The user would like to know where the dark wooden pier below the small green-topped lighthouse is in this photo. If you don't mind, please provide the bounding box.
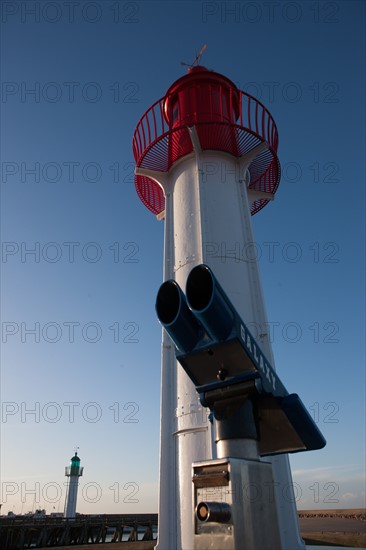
[0,514,158,550]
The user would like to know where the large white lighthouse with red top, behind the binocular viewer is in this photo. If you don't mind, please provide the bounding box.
[133,61,320,550]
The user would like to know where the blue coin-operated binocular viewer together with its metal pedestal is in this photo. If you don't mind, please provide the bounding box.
[156,264,325,550]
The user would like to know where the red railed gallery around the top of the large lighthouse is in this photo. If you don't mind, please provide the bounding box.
[133,85,280,214]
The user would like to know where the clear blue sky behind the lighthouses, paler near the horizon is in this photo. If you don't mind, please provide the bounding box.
[1,0,365,513]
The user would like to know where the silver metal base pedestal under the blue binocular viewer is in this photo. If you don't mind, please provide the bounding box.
[193,458,281,550]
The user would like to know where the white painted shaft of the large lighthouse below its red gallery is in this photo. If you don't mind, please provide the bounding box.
[147,129,305,550]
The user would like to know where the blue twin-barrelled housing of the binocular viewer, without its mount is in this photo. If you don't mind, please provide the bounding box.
[156,264,326,455]
